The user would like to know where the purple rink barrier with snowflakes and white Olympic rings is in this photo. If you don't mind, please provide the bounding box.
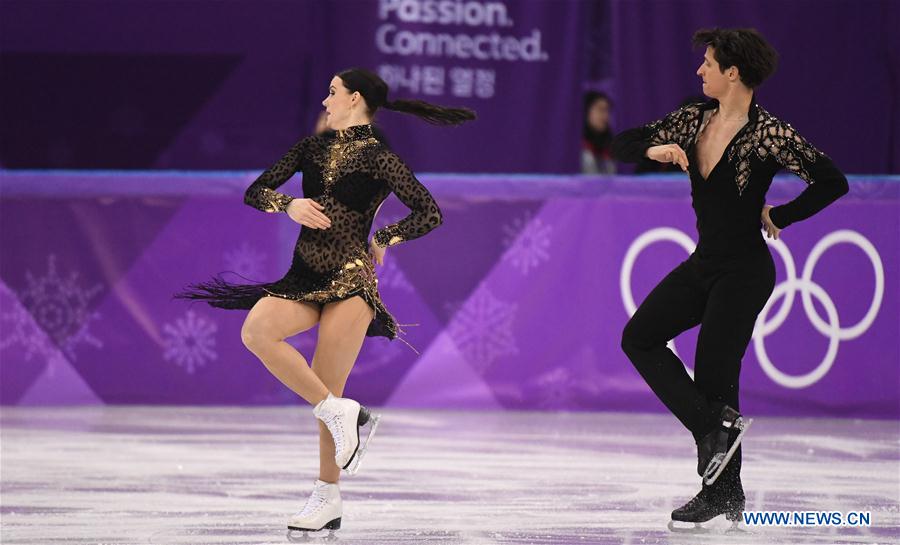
[0,171,900,419]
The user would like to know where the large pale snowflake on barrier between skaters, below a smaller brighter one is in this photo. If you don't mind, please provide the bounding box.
[447,286,519,374]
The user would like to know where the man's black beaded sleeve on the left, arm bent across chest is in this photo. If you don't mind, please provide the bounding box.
[612,104,701,163]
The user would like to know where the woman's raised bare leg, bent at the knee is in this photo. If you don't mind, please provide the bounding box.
[241,297,334,404]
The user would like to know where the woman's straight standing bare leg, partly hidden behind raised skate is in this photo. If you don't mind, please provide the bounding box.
[312,297,374,483]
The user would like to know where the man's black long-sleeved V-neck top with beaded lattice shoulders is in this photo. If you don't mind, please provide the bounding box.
[612,100,849,255]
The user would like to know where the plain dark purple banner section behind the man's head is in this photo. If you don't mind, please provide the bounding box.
[612,0,900,173]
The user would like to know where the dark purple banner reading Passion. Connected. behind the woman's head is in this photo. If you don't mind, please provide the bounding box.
[0,0,584,172]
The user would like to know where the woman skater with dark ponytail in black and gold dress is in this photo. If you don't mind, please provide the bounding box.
[177,68,475,535]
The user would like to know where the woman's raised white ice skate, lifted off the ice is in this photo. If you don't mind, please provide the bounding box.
[313,394,381,475]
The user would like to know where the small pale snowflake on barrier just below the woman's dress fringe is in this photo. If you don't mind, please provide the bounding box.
[163,310,218,374]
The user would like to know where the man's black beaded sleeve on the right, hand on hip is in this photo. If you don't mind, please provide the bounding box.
[760,117,850,229]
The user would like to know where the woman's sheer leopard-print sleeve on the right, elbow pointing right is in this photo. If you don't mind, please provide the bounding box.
[374,150,443,248]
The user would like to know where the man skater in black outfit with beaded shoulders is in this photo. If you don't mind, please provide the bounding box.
[613,28,848,527]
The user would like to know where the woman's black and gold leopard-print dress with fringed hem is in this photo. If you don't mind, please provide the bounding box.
[177,125,442,339]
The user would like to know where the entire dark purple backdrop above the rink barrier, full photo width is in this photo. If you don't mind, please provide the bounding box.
[0,0,900,173]
